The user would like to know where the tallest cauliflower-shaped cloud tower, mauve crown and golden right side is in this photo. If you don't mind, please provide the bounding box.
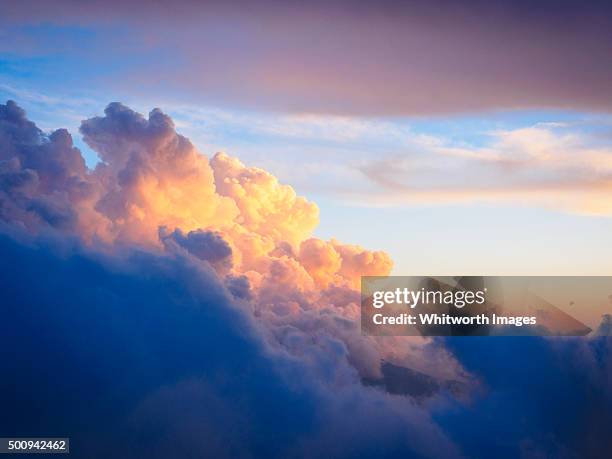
[81,103,238,242]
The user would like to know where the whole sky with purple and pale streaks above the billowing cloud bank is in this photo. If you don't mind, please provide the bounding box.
[0,1,612,275]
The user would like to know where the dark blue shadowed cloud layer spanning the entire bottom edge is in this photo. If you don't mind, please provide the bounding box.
[0,224,612,458]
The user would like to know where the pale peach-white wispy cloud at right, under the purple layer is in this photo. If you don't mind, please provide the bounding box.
[359,124,612,215]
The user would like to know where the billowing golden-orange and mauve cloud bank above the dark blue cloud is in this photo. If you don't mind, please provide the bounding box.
[2,103,430,396]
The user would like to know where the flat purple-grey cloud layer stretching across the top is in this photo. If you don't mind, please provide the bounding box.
[3,0,612,116]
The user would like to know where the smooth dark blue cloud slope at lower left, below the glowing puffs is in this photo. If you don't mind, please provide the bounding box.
[0,228,457,458]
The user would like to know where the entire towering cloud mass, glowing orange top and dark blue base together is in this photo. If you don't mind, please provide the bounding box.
[0,103,612,458]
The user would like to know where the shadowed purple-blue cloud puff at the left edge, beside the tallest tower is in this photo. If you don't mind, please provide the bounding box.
[0,101,92,234]
